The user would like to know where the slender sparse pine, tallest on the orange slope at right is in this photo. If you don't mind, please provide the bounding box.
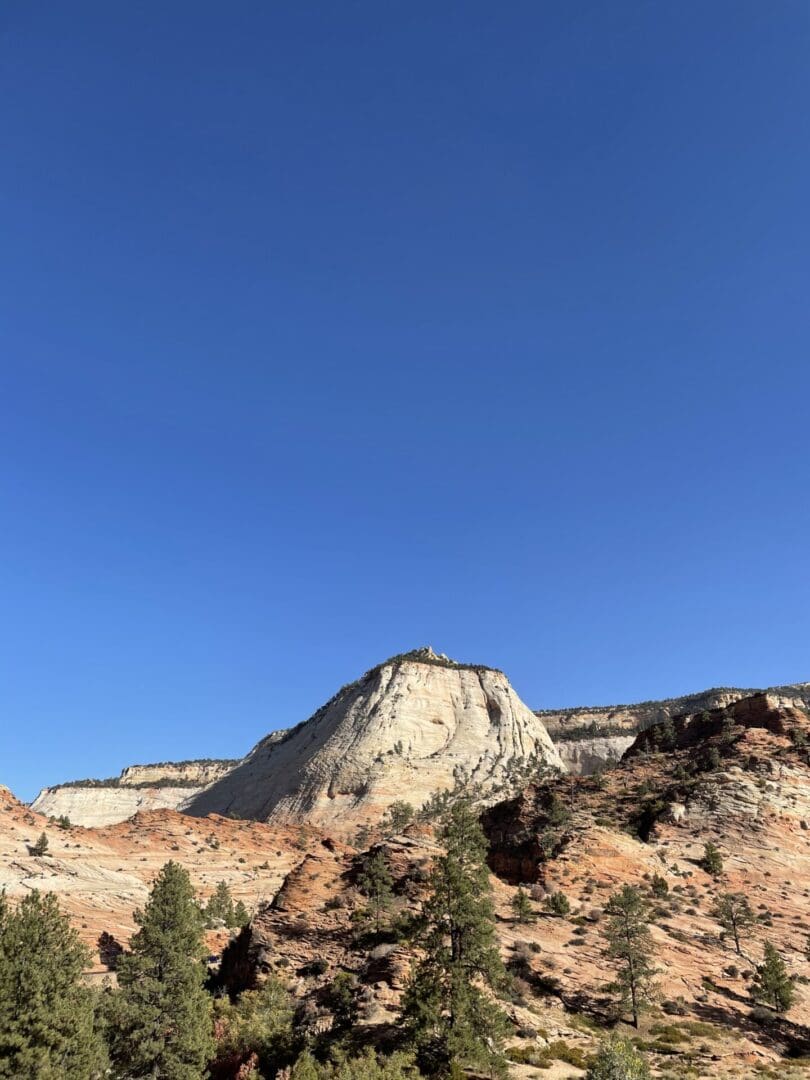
[605,885,656,1027]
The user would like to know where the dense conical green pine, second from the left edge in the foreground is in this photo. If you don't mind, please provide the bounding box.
[111,862,214,1080]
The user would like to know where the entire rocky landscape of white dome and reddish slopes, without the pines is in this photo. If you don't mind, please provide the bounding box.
[0,650,810,1080]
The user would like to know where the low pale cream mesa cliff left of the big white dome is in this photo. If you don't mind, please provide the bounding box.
[31,759,238,826]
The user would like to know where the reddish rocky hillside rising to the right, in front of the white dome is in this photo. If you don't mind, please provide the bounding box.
[213,694,810,1078]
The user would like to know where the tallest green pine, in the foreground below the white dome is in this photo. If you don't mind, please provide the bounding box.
[402,799,507,1075]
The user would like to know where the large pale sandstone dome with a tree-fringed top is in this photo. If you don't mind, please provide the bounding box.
[189,650,562,835]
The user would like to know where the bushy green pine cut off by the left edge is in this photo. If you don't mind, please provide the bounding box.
[0,891,107,1080]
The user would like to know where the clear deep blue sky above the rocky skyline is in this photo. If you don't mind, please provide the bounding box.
[0,0,810,797]
